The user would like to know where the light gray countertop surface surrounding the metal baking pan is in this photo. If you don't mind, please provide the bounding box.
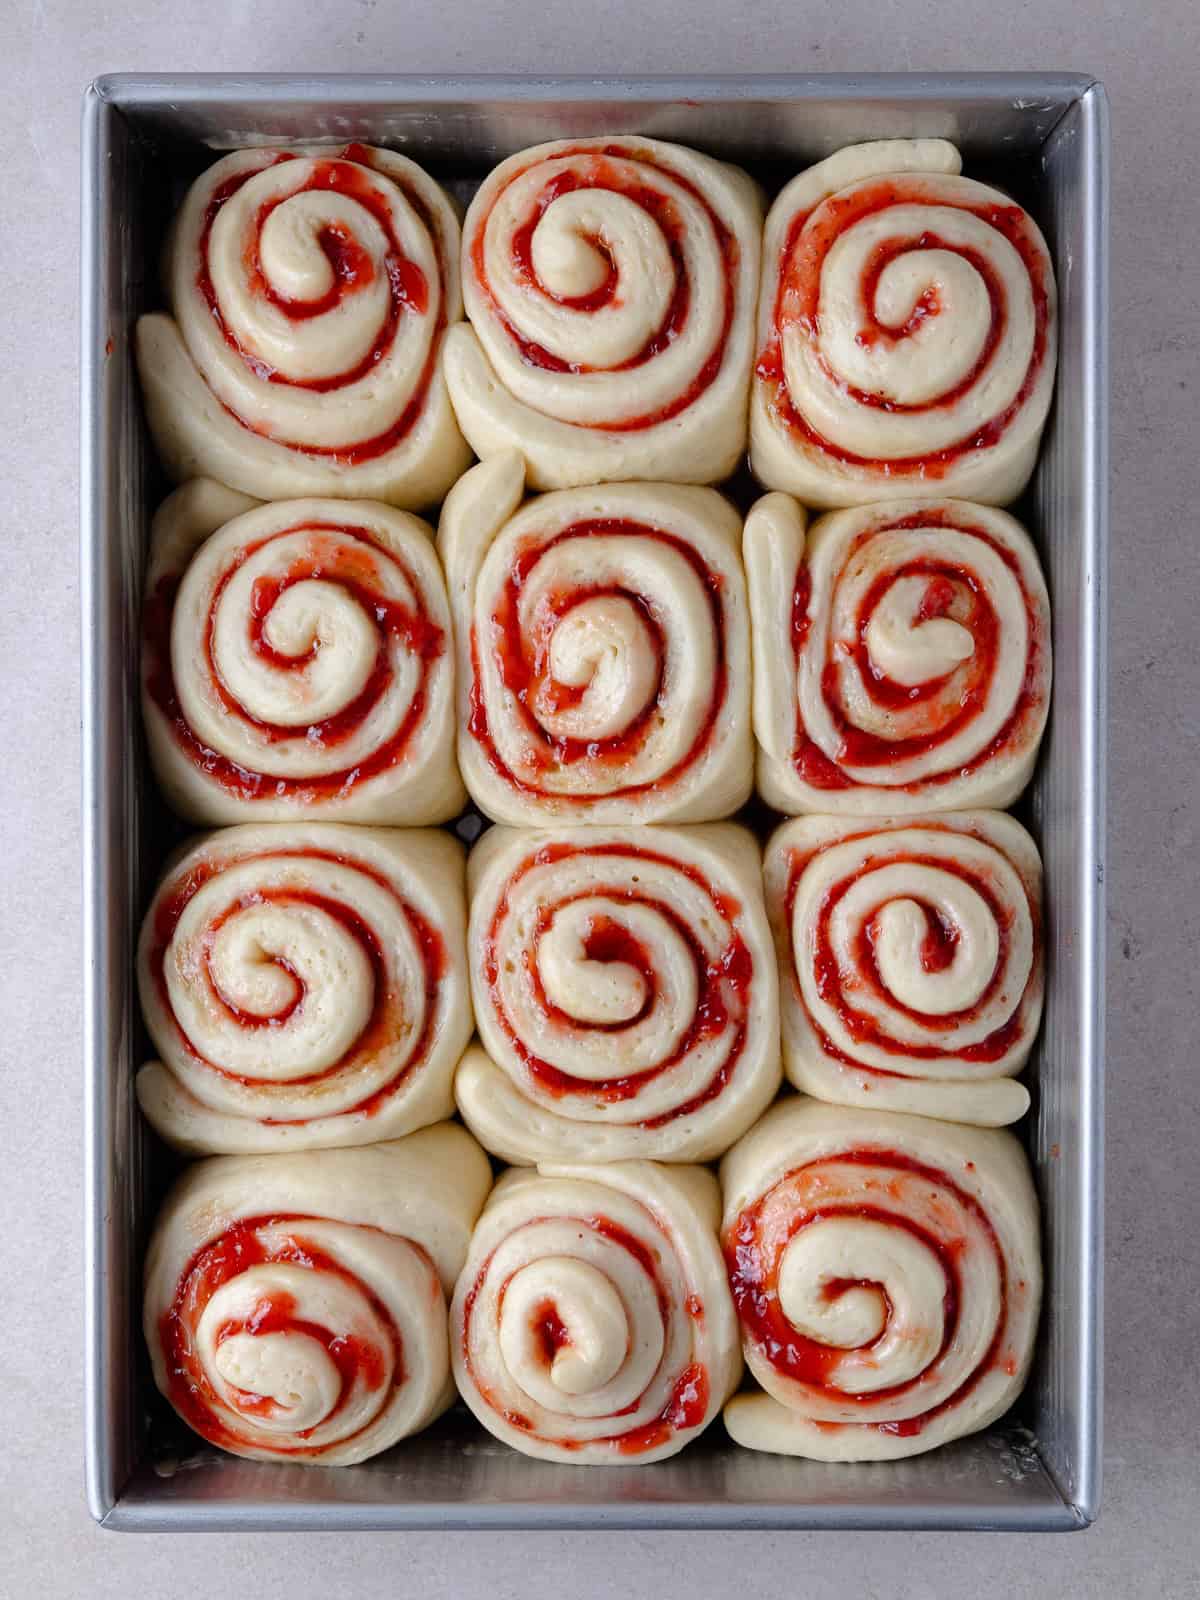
[0,0,1200,1600]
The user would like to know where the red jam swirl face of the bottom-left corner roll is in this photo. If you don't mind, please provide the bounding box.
[157,1216,405,1459]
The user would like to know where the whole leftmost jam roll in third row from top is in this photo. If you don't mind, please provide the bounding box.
[138,822,472,1154]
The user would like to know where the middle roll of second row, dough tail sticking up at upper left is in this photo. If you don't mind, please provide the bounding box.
[438,451,754,826]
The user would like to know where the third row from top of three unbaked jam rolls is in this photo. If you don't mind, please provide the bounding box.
[138,811,1043,1163]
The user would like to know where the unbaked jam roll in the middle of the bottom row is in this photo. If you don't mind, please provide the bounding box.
[450,1162,742,1466]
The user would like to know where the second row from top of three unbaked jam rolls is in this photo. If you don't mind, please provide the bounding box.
[142,451,1051,826]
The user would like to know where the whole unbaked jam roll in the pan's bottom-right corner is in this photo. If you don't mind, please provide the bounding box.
[722,1098,1042,1461]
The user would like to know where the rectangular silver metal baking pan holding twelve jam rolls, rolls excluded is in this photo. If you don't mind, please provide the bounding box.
[82,74,1107,1530]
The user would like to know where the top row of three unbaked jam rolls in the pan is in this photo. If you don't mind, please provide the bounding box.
[136,134,1056,510]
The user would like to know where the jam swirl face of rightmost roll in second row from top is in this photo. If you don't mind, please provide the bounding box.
[792,502,1050,803]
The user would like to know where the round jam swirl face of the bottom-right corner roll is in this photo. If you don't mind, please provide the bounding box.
[723,1147,1022,1438]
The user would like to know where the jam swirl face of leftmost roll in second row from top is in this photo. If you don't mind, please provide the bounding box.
[142,520,448,805]
